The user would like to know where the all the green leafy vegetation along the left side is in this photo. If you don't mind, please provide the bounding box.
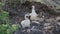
[0,2,20,34]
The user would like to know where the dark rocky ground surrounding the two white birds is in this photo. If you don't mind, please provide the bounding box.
[3,2,60,34]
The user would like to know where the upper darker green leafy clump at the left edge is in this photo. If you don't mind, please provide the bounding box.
[0,11,10,23]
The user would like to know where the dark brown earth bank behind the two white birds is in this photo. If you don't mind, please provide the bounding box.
[3,1,59,23]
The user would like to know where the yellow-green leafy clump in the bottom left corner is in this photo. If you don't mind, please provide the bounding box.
[0,24,19,34]
